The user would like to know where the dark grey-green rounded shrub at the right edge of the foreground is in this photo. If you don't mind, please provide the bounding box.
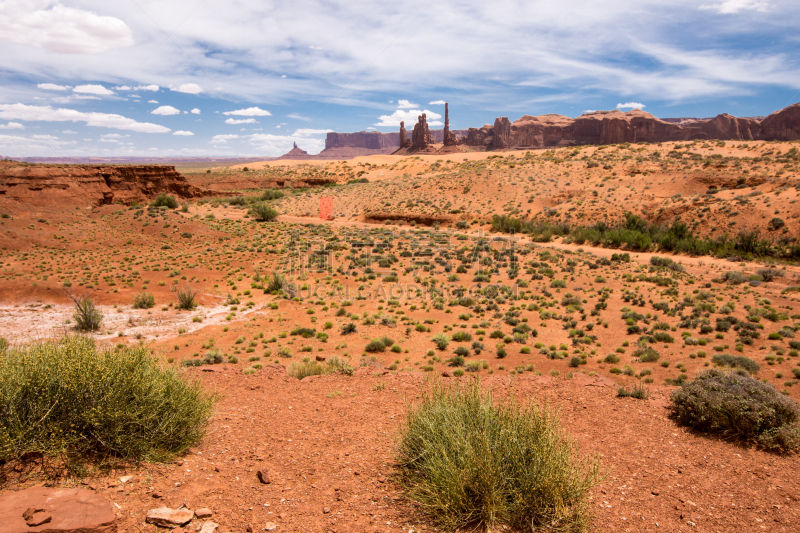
[670,369,800,451]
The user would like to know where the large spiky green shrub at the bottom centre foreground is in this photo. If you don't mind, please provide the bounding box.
[397,380,601,531]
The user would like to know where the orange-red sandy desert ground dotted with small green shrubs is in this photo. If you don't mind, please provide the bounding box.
[0,113,800,531]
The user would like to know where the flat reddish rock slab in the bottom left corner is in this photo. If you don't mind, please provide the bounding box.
[0,487,117,533]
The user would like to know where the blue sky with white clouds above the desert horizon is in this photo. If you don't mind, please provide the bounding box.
[0,0,800,157]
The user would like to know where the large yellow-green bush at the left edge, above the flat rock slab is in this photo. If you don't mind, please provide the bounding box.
[0,336,216,461]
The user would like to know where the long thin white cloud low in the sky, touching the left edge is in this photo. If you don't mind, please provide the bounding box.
[0,104,171,133]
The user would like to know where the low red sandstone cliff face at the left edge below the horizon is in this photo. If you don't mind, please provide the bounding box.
[0,162,208,206]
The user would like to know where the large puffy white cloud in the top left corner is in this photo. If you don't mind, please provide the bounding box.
[0,0,133,54]
